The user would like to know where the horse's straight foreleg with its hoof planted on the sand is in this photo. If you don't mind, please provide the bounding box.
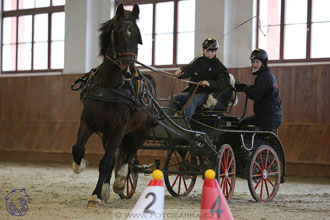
[87,129,124,208]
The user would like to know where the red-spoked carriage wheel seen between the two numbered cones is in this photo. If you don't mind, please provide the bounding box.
[164,150,197,197]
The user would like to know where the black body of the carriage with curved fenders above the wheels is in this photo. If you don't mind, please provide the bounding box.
[141,113,285,180]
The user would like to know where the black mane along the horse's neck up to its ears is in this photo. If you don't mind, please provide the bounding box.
[99,9,139,57]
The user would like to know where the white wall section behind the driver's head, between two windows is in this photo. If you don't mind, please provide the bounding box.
[195,0,256,67]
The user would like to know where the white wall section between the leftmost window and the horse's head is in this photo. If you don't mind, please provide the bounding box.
[64,0,113,74]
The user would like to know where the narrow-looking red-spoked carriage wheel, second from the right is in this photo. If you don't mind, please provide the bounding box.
[215,144,236,201]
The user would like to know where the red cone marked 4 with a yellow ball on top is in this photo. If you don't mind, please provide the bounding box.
[200,169,234,220]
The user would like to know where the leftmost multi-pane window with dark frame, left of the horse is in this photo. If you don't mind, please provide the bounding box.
[1,0,65,73]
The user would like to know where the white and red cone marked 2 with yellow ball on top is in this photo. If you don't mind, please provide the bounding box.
[127,170,165,220]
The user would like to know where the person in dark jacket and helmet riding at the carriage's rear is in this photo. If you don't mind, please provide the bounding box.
[241,49,283,131]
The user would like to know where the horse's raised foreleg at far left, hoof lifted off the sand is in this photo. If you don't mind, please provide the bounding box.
[72,120,93,174]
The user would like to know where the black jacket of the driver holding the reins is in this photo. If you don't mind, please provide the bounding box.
[179,56,229,94]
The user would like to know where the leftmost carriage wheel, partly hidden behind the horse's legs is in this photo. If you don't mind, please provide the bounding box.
[115,150,139,199]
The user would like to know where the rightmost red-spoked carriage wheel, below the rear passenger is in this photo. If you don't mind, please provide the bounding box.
[248,145,281,202]
